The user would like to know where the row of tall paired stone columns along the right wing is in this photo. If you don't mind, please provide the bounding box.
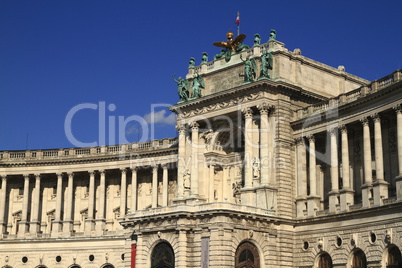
[295,105,402,217]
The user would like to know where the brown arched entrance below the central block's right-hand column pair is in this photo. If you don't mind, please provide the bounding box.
[235,242,260,268]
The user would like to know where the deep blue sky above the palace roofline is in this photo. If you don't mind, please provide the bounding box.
[0,0,402,150]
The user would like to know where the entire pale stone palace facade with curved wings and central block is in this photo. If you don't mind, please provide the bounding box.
[0,32,402,268]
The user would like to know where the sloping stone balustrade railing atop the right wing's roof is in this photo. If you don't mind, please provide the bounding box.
[296,70,402,120]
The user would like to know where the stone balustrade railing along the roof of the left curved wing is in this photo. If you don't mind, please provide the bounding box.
[0,138,177,161]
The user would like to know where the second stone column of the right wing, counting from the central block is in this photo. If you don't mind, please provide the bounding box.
[307,135,320,216]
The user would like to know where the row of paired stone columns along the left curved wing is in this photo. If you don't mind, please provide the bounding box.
[0,164,168,238]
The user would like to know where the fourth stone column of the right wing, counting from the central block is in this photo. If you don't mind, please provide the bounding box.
[339,125,354,211]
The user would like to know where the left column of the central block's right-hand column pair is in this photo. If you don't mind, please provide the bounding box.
[241,108,254,206]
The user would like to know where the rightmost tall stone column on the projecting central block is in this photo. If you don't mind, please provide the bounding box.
[258,103,272,186]
